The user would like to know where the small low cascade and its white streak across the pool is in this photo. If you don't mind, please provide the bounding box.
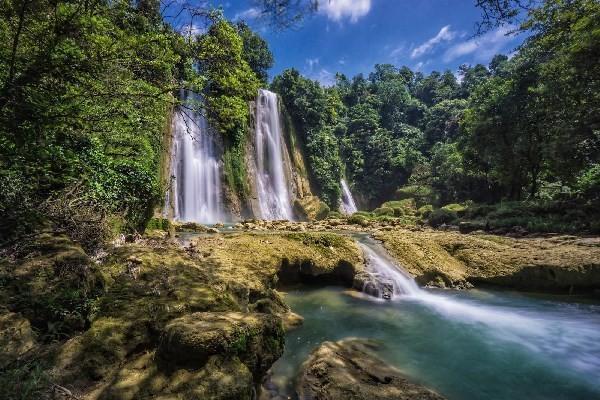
[361,241,600,378]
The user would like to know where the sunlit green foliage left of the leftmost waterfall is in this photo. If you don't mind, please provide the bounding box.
[0,1,180,241]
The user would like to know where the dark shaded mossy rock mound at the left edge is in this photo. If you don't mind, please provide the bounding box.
[0,233,103,340]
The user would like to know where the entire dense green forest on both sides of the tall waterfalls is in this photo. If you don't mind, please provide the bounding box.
[0,0,600,246]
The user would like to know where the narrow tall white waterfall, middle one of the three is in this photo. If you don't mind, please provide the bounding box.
[255,89,293,220]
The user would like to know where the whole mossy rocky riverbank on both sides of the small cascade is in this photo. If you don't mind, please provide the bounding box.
[0,225,600,399]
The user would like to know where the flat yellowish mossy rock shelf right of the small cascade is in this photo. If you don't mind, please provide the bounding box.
[377,230,600,291]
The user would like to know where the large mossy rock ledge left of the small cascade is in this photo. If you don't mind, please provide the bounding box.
[0,232,363,400]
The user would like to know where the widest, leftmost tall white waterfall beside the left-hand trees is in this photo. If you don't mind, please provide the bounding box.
[168,91,224,223]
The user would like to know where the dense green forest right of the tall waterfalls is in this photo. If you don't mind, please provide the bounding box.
[272,1,600,222]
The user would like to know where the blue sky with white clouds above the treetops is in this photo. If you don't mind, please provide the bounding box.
[197,0,523,85]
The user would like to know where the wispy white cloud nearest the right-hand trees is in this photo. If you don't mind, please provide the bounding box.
[444,26,514,62]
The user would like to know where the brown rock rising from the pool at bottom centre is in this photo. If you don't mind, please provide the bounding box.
[296,339,444,400]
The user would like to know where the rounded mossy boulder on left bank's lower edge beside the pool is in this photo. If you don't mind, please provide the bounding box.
[158,312,284,378]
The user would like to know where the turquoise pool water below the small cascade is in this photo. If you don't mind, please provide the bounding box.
[272,288,600,400]
